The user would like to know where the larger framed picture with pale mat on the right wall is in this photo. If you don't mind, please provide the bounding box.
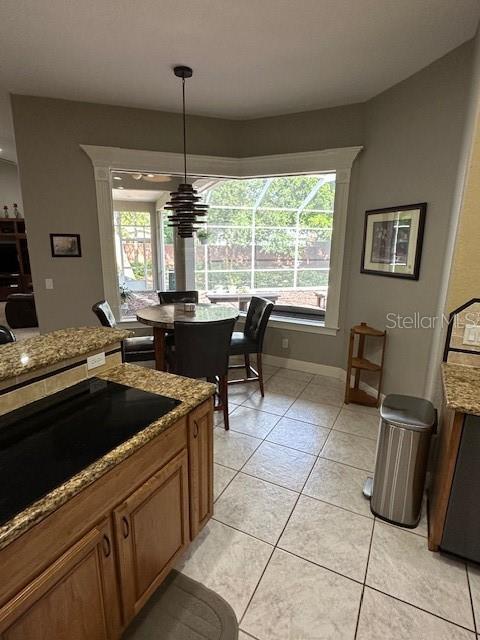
[361,202,427,280]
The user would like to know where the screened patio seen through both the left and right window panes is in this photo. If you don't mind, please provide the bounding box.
[114,172,335,319]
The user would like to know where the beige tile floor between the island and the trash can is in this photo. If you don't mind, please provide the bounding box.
[173,367,480,640]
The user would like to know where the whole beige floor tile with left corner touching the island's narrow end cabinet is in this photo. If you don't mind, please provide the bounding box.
[215,473,298,544]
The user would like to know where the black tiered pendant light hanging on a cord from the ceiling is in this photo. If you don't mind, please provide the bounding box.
[165,66,208,238]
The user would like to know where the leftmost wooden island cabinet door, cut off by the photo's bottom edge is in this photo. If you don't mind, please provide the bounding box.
[0,520,119,640]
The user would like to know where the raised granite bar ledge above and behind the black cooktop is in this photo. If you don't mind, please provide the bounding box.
[0,327,133,381]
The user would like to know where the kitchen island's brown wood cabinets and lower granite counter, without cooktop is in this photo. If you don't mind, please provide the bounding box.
[0,335,214,640]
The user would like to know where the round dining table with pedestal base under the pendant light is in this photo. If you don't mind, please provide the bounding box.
[137,302,239,371]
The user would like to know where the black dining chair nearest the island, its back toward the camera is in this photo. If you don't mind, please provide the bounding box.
[166,318,235,430]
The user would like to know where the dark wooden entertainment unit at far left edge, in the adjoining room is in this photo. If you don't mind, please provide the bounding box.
[0,218,33,302]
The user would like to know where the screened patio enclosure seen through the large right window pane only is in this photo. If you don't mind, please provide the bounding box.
[195,173,335,313]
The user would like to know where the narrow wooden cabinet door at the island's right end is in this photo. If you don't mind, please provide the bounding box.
[188,402,213,540]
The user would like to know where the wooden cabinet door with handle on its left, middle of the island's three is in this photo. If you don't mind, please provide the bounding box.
[114,449,189,624]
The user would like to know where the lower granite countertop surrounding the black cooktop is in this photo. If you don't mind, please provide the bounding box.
[0,364,215,549]
